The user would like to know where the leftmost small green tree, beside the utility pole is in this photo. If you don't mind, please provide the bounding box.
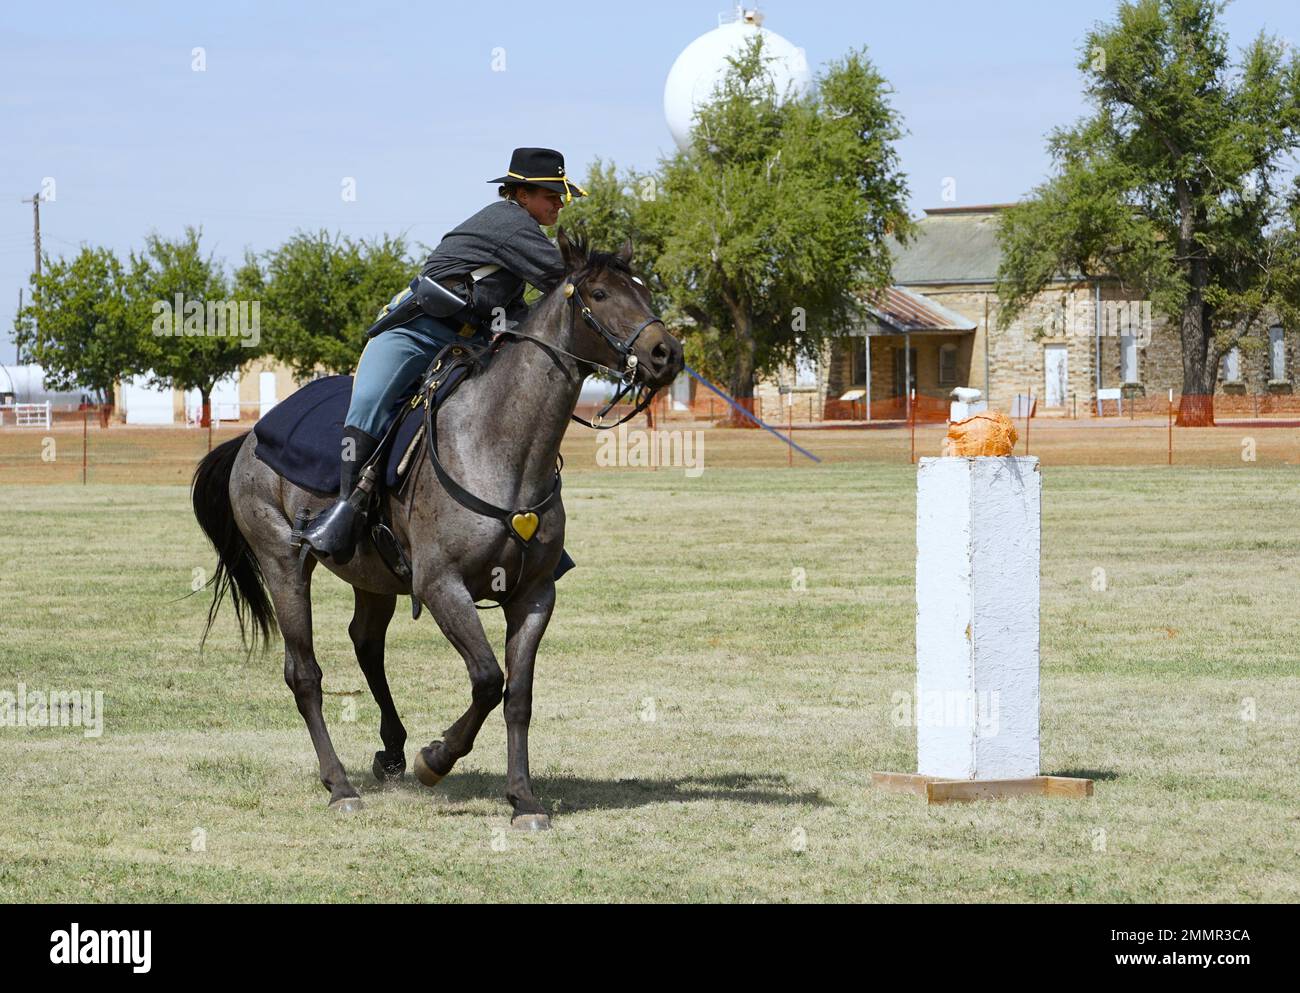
[14,246,140,403]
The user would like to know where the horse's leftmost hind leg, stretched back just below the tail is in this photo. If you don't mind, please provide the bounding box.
[267,556,361,811]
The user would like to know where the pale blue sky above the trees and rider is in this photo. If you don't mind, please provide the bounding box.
[0,0,1300,363]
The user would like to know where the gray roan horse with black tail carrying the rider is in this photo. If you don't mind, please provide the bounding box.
[192,230,683,829]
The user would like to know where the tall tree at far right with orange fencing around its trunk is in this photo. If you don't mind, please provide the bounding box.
[998,0,1300,426]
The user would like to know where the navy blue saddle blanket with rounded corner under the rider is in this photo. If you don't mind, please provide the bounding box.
[252,376,458,494]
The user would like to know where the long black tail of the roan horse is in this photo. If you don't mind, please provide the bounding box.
[190,432,276,651]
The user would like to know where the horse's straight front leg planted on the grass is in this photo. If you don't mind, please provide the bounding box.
[504,576,555,831]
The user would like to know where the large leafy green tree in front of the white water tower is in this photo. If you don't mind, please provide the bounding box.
[564,35,913,415]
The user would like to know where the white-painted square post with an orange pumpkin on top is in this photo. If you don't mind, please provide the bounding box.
[915,456,1043,780]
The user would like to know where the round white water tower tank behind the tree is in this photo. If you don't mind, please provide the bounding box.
[663,5,813,151]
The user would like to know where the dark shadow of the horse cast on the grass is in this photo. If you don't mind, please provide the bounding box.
[354,769,831,814]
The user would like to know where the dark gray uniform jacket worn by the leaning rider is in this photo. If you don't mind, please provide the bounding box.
[420,200,564,321]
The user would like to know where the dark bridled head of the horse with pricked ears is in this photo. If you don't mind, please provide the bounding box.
[555,227,684,389]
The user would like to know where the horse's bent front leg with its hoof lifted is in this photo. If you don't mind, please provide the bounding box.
[415,578,506,786]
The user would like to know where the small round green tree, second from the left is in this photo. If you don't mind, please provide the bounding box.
[130,227,260,425]
